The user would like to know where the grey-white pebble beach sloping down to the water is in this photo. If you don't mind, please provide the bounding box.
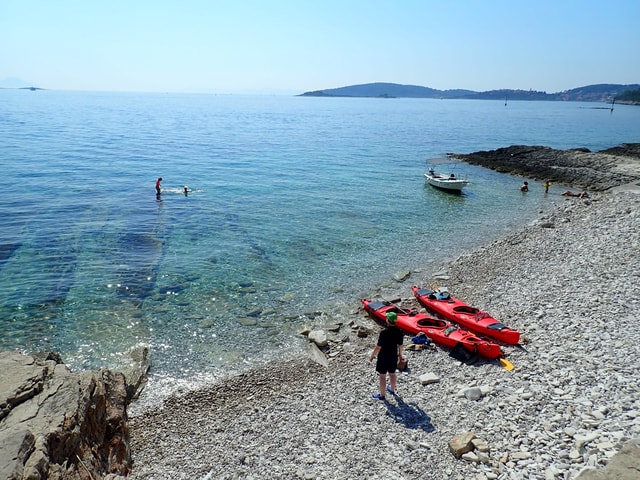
[129,161,640,480]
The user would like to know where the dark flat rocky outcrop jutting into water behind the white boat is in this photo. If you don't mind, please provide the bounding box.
[451,143,640,191]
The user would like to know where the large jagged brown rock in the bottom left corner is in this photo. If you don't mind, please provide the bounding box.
[0,352,147,480]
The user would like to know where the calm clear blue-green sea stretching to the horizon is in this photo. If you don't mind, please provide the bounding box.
[0,90,640,402]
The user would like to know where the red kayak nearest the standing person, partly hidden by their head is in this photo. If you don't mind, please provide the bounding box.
[360,298,504,359]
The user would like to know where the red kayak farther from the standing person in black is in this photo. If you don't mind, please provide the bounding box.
[411,286,520,345]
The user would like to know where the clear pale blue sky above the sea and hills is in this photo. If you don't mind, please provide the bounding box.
[0,0,640,94]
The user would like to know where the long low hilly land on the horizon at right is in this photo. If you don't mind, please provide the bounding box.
[299,83,640,105]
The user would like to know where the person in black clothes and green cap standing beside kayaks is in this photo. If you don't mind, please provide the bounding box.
[369,312,404,400]
